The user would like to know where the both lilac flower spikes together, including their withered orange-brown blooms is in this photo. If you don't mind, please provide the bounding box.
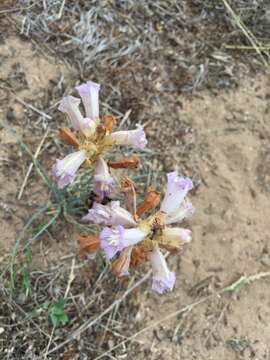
[52,81,194,294]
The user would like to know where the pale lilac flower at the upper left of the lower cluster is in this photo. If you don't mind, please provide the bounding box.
[83,201,136,226]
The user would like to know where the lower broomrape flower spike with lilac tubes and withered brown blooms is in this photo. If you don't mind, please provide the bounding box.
[84,171,194,294]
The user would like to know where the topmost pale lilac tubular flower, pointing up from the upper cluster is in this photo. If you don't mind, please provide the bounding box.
[76,81,100,121]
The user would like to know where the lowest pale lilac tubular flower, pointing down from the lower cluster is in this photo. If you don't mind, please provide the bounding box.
[149,247,175,294]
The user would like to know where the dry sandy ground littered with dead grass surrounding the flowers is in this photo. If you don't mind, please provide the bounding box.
[0,1,270,360]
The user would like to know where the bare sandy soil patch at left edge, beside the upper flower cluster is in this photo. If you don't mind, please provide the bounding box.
[0,36,71,255]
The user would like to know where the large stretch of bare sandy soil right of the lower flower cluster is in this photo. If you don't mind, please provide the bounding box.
[138,77,270,359]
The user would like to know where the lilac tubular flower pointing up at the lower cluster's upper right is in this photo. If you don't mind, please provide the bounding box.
[160,171,193,215]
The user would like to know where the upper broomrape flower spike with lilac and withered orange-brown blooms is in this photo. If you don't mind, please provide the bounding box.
[52,81,147,198]
